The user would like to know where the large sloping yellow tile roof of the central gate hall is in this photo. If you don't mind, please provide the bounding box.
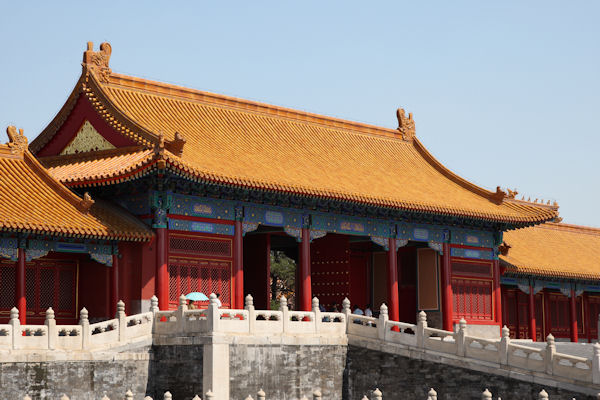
[32,45,556,225]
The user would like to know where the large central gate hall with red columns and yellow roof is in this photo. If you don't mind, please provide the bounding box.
[0,43,572,334]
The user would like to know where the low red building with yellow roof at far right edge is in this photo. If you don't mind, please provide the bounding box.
[500,223,600,342]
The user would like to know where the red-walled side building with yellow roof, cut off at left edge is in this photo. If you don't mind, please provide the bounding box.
[0,127,153,323]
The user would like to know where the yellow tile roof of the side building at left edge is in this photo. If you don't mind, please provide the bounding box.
[0,127,153,241]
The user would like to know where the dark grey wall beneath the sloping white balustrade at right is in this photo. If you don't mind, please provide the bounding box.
[343,345,596,400]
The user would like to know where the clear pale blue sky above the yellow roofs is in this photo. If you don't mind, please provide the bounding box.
[0,1,600,227]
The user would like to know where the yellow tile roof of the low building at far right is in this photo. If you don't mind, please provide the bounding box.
[500,222,600,280]
